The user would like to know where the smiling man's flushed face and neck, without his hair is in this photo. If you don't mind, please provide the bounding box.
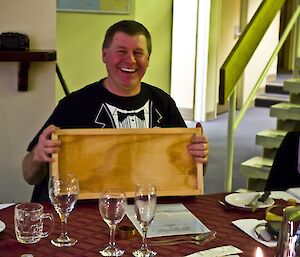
[102,32,149,96]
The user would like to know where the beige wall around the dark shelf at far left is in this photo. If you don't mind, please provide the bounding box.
[0,0,56,202]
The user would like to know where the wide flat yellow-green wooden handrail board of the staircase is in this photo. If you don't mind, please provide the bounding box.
[219,0,286,104]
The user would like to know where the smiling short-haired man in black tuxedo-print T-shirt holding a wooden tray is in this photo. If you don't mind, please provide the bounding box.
[23,20,208,201]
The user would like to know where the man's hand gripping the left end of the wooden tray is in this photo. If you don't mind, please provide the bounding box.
[33,125,60,162]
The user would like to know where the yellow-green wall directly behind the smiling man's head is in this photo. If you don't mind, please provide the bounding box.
[56,0,172,101]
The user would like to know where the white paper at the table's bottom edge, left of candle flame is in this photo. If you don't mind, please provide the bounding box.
[186,245,243,257]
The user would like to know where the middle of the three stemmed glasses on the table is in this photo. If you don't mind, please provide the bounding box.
[99,189,127,256]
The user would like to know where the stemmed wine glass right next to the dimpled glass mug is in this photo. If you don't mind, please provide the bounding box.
[49,174,79,247]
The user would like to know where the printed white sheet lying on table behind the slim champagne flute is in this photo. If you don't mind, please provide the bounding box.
[126,204,210,238]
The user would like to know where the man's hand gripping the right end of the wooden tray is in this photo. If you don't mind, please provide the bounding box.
[188,122,208,164]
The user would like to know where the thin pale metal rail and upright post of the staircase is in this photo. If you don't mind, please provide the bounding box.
[220,2,300,192]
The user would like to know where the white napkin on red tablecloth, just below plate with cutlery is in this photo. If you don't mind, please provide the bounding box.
[232,219,277,247]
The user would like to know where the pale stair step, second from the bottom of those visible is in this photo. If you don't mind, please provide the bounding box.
[256,129,287,149]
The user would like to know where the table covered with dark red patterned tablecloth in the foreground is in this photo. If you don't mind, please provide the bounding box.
[0,193,276,257]
